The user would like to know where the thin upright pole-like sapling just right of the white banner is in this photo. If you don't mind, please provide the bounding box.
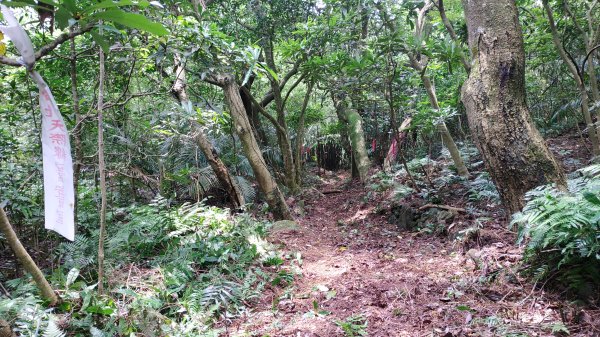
[98,48,107,294]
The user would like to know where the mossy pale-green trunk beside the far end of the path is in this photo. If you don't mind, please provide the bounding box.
[334,98,371,183]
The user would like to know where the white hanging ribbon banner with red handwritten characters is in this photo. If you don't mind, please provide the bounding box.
[0,5,75,241]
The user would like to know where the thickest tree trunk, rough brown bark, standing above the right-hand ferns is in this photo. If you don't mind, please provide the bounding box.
[462,0,565,213]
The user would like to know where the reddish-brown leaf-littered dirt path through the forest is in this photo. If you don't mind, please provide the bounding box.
[227,172,594,337]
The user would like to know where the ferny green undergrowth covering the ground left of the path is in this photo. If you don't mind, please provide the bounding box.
[0,199,294,336]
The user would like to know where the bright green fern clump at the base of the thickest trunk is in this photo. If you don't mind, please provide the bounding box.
[512,165,600,301]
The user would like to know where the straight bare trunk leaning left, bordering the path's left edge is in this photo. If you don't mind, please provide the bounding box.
[217,75,292,220]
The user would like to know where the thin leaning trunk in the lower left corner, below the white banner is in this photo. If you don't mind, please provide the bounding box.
[0,207,58,306]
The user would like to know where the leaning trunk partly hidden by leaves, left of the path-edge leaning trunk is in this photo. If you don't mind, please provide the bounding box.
[171,55,245,209]
